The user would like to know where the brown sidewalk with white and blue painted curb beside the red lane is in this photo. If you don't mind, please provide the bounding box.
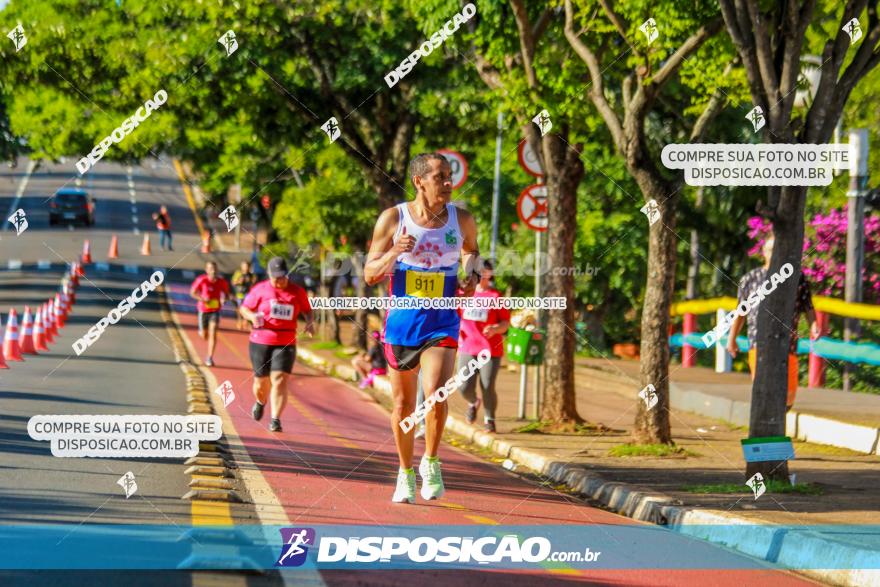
[298,324,880,585]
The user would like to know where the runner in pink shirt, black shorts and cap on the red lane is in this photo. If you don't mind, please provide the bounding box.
[239,257,315,432]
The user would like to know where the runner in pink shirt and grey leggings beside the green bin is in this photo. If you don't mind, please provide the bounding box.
[455,261,510,432]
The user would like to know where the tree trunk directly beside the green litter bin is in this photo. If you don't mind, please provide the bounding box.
[541,135,584,423]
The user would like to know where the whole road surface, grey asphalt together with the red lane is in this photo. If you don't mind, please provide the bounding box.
[0,161,824,586]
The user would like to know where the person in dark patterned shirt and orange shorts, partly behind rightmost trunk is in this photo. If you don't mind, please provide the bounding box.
[727,235,822,411]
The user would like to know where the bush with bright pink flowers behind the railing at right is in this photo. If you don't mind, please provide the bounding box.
[748,206,880,304]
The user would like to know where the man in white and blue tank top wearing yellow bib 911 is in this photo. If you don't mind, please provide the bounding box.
[364,153,479,503]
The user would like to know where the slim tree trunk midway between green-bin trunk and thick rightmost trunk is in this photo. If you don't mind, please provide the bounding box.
[633,171,678,444]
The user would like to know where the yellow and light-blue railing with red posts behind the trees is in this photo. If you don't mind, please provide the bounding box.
[669,296,880,387]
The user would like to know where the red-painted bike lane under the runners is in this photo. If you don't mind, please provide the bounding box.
[170,285,812,586]
